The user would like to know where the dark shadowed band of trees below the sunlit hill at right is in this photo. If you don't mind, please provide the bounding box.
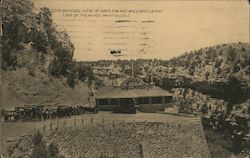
[158,76,250,104]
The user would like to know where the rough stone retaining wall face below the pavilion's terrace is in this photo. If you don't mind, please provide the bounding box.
[45,122,210,158]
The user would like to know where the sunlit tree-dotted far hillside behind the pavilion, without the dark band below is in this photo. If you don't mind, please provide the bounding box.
[89,42,250,83]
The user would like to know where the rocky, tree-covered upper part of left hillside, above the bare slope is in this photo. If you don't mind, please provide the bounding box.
[1,0,94,88]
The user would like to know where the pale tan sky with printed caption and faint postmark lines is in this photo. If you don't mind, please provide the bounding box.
[33,0,249,61]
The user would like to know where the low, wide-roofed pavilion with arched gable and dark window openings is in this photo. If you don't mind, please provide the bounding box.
[95,64,172,113]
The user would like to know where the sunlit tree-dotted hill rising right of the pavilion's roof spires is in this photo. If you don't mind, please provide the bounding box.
[156,42,250,85]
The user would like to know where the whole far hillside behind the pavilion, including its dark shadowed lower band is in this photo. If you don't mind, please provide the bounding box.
[88,42,250,104]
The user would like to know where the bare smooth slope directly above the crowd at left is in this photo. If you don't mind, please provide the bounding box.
[1,68,92,109]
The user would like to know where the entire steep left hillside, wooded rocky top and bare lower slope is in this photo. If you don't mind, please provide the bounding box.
[0,0,95,109]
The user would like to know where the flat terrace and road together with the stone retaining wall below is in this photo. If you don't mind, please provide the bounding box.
[1,112,209,157]
